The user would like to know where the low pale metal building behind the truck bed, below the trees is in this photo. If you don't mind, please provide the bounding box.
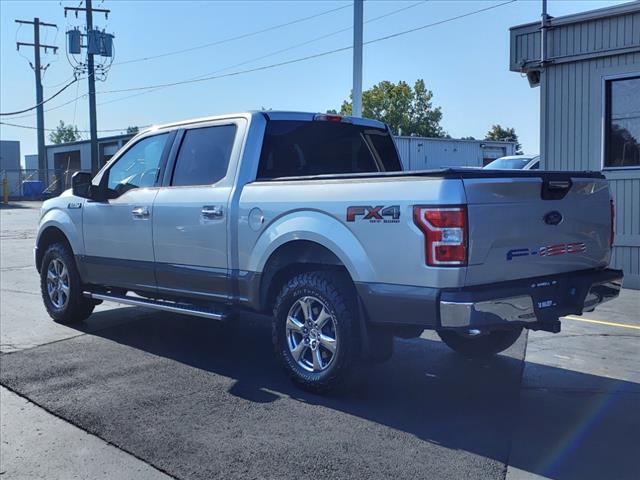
[395,136,516,170]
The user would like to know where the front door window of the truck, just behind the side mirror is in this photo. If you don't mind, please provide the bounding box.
[108,133,169,195]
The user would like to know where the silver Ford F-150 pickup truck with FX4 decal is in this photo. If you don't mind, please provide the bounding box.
[35,112,622,391]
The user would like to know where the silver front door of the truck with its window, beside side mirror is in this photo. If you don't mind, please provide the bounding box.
[84,132,175,290]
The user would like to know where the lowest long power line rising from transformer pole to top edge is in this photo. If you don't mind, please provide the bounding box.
[99,0,517,94]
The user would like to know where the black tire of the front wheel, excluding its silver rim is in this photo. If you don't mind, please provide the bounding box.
[40,243,95,324]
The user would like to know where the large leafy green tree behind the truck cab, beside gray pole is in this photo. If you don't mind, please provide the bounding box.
[336,79,446,137]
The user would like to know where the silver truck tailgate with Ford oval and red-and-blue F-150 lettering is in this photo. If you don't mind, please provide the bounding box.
[463,172,611,285]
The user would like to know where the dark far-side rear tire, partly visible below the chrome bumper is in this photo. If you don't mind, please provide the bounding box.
[437,328,522,358]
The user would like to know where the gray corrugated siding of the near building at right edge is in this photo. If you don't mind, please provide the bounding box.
[511,4,640,288]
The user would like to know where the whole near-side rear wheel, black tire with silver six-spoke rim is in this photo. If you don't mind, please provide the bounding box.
[273,271,359,393]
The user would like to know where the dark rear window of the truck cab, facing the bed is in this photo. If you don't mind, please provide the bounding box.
[258,120,402,179]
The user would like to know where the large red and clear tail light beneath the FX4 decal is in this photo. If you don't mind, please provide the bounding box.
[413,205,467,267]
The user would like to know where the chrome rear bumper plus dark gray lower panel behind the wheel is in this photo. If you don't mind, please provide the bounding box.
[357,269,623,331]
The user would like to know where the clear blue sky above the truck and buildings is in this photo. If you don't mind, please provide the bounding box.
[0,0,624,162]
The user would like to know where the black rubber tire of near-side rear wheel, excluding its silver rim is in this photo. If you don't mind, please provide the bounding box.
[273,271,360,393]
